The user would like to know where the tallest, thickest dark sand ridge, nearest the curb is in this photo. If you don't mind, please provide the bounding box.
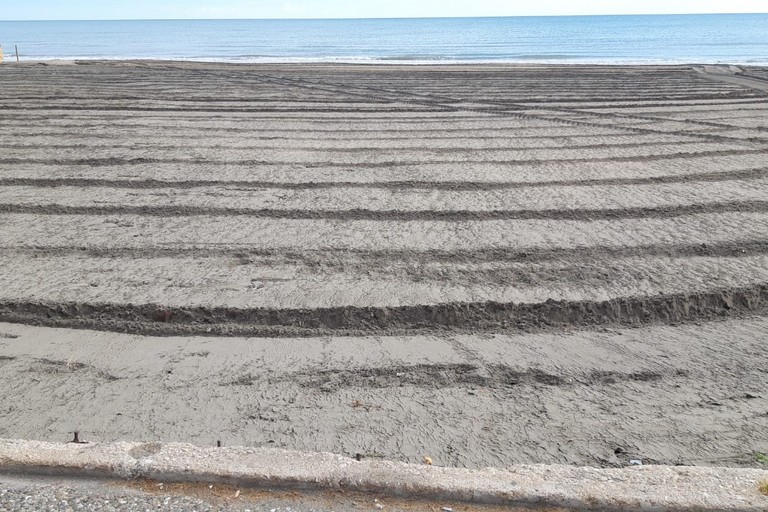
[0,284,768,338]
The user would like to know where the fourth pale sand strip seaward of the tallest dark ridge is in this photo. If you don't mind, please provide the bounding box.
[0,158,768,190]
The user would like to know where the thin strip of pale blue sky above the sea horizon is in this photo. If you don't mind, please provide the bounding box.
[0,0,768,20]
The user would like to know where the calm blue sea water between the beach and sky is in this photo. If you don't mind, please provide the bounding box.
[0,14,768,65]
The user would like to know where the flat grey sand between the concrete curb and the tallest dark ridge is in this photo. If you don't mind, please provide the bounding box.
[0,318,768,468]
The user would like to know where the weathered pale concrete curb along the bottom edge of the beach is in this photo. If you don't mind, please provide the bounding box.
[0,440,768,511]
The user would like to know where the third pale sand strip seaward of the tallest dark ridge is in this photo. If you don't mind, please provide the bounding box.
[6,176,768,213]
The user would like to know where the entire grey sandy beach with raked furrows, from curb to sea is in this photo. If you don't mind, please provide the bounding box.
[0,61,768,468]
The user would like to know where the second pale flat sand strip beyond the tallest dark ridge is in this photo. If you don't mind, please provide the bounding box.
[0,212,768,251]
